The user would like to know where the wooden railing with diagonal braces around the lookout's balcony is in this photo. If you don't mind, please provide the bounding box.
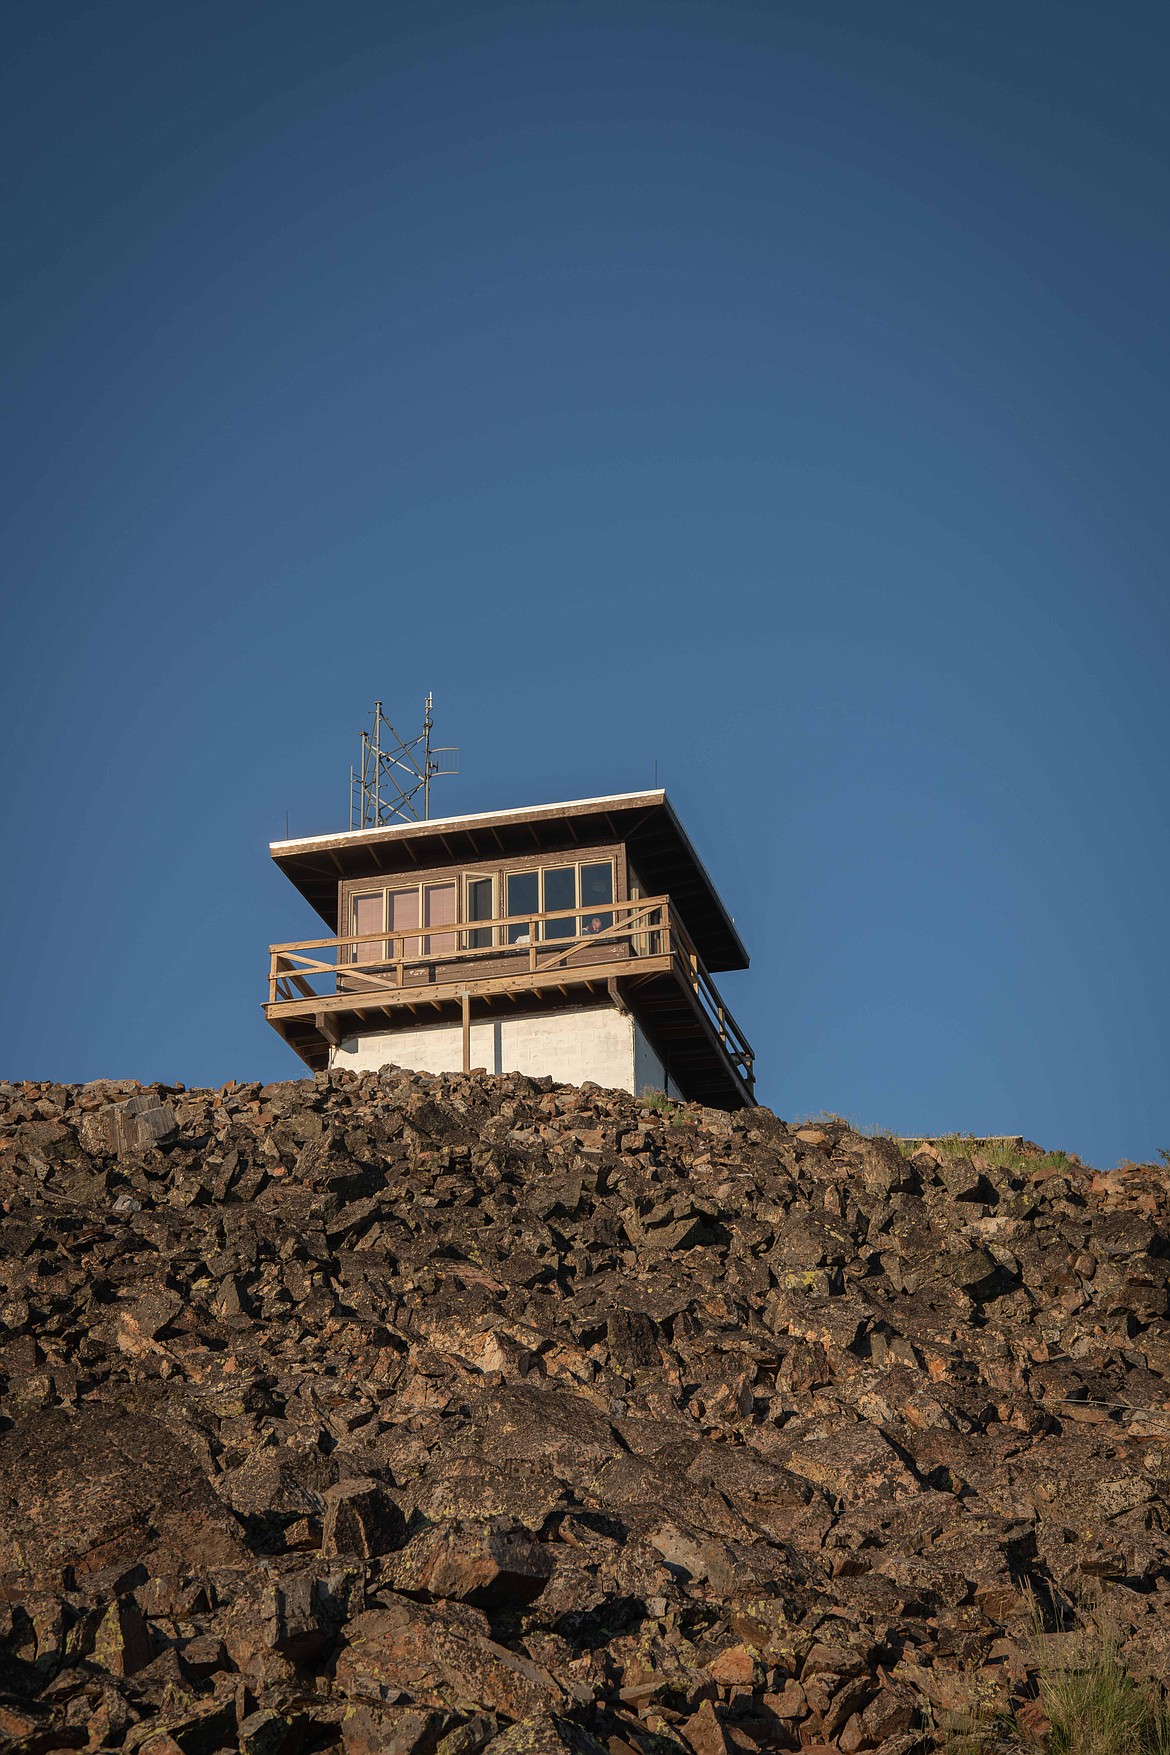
[268,895,753,1085]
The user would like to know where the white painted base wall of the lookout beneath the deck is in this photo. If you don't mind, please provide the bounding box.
[330,1006,677,1095]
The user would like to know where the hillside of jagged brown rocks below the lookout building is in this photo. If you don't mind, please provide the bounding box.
[0,1071,1170,1755]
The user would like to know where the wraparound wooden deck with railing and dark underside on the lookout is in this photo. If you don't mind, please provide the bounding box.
[265,895,754,1107]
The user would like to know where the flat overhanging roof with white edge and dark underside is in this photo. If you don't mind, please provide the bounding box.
[268,790,747,971]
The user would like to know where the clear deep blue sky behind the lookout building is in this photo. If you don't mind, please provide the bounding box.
[0,0,1170,1164]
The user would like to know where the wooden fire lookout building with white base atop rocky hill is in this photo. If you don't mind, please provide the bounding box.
[265,792,754,1109]
